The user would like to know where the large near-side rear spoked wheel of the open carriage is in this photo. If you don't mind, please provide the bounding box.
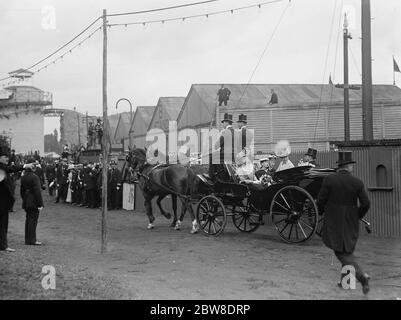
[270,186,318,243]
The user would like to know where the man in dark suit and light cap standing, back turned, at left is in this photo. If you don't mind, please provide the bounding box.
[21,163,43,246]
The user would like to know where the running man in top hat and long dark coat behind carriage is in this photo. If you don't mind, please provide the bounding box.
[317,151,370,294]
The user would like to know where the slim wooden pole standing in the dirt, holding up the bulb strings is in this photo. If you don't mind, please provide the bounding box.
[101,9,109,253]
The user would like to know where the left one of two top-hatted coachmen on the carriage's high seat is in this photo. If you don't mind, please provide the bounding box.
[209,113,235,180]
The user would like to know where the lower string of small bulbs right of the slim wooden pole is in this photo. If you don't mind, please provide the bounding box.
[107,0,282,27]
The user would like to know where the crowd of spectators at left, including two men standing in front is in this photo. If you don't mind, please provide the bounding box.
[0,145,129,252]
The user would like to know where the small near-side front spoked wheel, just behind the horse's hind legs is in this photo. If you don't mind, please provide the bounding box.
[196,196,227,237]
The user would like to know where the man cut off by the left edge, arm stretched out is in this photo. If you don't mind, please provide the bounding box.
[0,145,22,252]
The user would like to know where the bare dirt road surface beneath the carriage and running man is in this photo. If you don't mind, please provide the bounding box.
[0,192,401,299]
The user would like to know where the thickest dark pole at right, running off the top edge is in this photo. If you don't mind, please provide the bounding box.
[361,0,373,141]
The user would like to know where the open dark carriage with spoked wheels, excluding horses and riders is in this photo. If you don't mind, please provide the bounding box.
[196,164,335,243]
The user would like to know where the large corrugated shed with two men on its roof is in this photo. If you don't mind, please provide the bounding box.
[178,84,401,152]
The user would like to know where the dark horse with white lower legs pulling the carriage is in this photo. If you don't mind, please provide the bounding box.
[127,148,198,233]
